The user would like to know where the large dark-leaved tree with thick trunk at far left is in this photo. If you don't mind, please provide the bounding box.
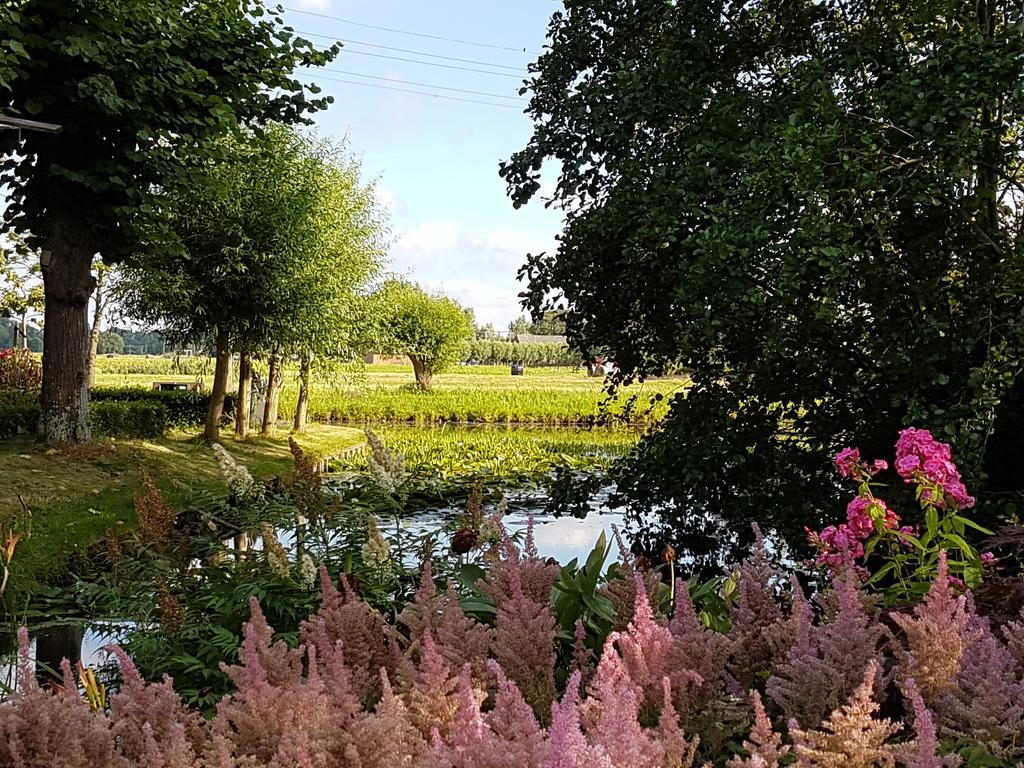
[0,0,338,442]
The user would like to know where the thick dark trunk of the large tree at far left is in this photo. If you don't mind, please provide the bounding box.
[39,231,94,443]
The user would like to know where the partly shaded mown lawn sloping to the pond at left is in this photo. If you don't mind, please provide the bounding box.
[0,425,365,606]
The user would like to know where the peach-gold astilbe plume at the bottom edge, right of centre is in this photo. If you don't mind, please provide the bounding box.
[790,662,899,768]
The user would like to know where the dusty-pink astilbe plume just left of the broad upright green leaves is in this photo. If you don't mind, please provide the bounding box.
[494,570,558,717]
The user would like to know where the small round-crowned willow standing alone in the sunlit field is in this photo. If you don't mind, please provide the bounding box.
[374,280,473,389]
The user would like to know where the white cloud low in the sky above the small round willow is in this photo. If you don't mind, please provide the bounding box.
[390,221,554,329]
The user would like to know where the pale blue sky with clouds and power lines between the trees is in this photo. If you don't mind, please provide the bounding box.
[281,0,561,330]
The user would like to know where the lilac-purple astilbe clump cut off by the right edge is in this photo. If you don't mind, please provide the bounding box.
[935,618,1024,759]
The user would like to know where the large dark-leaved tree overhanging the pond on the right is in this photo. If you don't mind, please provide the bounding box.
[502,0,1024,564]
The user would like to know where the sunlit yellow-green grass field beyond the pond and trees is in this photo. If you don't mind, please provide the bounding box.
[96,357,688,426]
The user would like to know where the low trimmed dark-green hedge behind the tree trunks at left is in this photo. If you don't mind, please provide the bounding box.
[0,387,234,439]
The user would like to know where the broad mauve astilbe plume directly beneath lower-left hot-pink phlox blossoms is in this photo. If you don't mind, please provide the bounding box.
[765,569,886,727]
